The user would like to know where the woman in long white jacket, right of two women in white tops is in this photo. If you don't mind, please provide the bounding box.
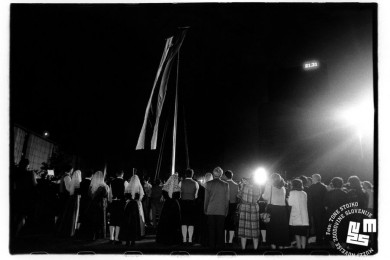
[288,179,309,249]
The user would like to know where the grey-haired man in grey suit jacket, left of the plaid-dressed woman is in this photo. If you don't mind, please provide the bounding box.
[204,167,229,249]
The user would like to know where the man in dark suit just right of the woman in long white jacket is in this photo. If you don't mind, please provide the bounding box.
[307,174,328,245]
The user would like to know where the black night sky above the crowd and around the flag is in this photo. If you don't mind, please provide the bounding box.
[10,3,375,181]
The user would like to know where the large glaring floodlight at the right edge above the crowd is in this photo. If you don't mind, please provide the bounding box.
[341,103,374,138]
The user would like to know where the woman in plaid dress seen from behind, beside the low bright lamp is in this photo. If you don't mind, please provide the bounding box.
[237,177,261,250]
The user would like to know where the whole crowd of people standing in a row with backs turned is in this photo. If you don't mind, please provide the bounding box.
[11,159,374,250]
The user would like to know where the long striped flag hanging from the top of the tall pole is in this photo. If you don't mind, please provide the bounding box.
[136,29,187,150]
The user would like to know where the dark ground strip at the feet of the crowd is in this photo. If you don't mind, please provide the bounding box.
[10,226,337,255]
